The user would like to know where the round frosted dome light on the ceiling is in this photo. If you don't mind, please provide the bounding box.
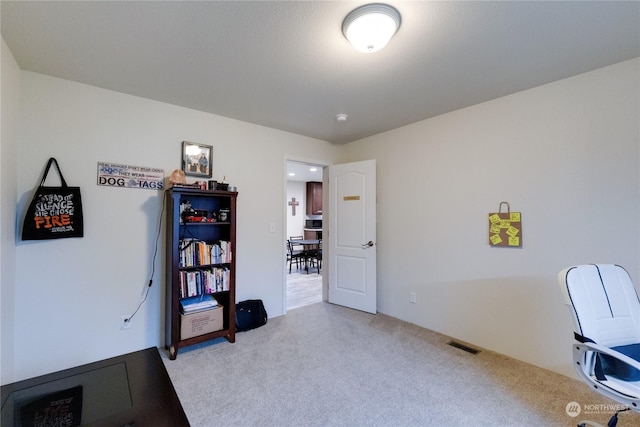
[342,3,401,53]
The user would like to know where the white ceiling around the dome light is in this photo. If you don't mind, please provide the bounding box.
[0,0,640,144]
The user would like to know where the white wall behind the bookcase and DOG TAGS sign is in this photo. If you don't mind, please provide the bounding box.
[3,71,338,381]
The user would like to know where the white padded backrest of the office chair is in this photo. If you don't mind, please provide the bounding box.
[558,264,640,347]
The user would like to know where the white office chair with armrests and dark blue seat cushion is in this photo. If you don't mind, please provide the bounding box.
[558,264,640,425]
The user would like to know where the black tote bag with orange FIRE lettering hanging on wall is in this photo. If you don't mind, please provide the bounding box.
[22,157,83,240]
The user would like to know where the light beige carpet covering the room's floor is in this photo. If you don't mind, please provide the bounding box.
[162,302,640,427]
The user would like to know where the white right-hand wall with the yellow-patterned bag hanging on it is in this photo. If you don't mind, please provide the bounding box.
[345,59,640,376]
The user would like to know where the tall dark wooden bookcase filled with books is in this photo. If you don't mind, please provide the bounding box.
[165,188,238,360]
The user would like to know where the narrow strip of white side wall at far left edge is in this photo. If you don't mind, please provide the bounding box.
[0,39,20,384]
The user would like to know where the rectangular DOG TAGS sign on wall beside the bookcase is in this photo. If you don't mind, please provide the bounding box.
[98,162,164,190]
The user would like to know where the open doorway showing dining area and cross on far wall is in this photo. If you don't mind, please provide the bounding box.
[285,160,324,311]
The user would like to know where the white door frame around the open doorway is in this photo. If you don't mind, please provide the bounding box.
[280,154,333,315]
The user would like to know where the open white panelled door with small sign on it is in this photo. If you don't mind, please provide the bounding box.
[325,160,377,313]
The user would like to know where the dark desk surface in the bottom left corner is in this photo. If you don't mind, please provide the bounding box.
[1,347,189,427]
